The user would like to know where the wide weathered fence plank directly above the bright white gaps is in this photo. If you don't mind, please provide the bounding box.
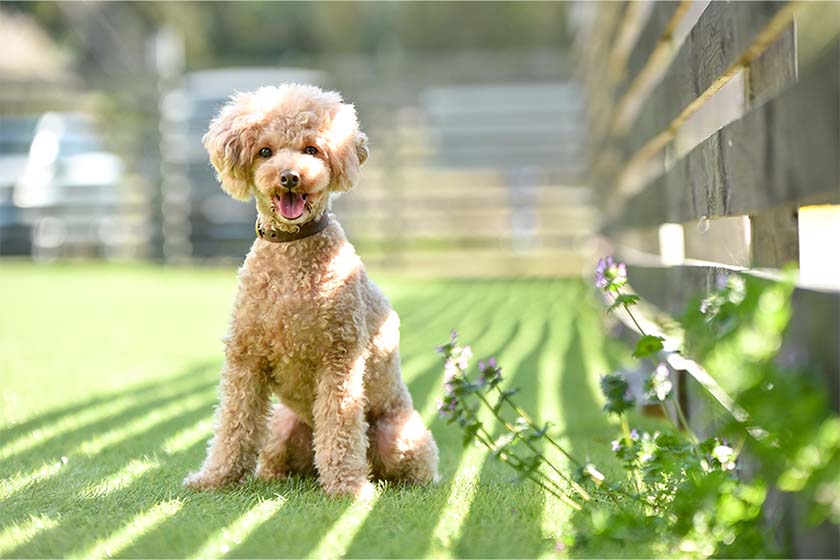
[610,42,840,231]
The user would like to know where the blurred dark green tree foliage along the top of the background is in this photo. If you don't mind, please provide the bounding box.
[5,2,568,75]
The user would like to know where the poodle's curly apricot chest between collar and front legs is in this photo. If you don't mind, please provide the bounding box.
[234,234,365,417]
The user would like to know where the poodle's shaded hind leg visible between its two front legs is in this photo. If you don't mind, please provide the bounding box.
[257,404,315,480]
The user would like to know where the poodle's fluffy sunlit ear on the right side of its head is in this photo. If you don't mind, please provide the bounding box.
[326,103,370,192]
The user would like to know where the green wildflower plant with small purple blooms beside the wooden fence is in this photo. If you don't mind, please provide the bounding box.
[437,257,840,557]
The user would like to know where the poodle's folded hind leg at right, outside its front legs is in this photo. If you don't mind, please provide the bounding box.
[370,409,438,484]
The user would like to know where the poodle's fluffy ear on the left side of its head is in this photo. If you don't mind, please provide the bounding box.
[202,95,263,200]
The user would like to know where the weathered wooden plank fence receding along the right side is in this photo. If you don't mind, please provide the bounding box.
[574,1,840,557]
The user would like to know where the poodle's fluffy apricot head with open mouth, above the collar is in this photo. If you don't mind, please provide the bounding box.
[203,84,368,231]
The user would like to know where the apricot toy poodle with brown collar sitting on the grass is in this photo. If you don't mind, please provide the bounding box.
[185,84,438,496]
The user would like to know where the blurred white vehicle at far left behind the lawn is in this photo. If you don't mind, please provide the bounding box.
[13,113,124,257]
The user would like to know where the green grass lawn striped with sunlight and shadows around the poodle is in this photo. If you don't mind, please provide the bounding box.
[0,263,628,557]
